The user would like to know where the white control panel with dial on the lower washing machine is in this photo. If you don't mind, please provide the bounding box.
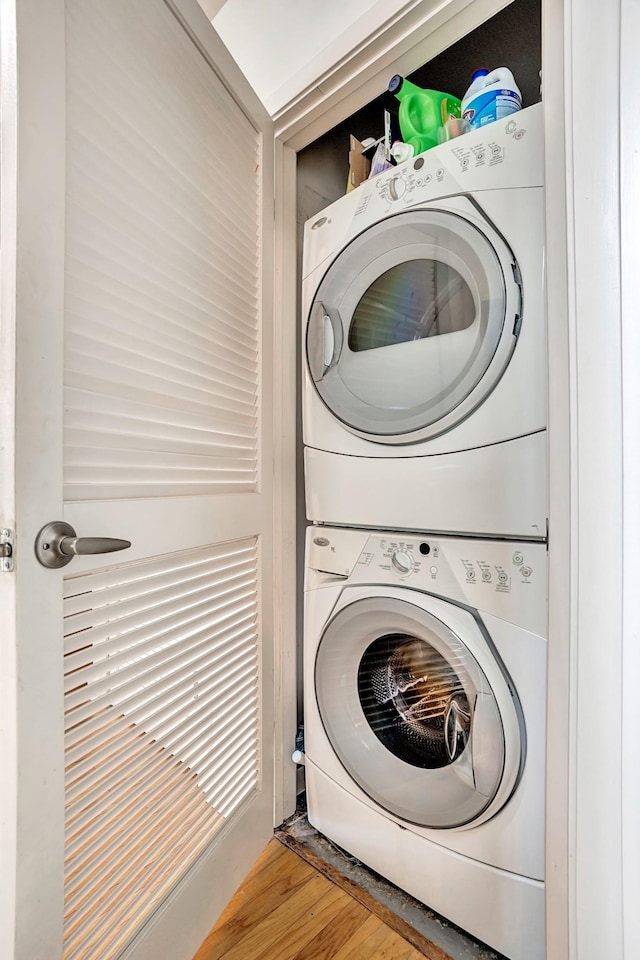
[306,526,547,636]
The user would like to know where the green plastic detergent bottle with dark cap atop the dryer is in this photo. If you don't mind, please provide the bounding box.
[389,74,460,153]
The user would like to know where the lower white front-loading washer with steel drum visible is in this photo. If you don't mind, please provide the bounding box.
[304,526,547,960]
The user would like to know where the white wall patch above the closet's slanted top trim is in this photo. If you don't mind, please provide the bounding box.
[212,0,415,115]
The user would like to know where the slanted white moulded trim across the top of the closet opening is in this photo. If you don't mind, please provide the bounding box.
[274,0,511,150]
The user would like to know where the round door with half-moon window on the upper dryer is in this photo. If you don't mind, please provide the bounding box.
[306,200,521,443]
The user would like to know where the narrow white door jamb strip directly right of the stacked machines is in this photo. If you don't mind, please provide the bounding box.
[542,3,577,960]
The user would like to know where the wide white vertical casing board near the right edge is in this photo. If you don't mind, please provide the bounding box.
[565,0,626,960]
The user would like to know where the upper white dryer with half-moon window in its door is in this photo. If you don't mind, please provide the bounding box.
[302,104,548,539]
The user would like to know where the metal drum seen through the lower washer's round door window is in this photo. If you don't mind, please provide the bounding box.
[358,634,472,770]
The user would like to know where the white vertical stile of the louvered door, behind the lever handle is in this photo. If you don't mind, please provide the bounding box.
[0,0,65,960]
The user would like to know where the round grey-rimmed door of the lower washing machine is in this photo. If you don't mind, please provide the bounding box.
[315,597,522,828]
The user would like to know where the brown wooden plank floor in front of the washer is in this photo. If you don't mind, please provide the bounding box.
[194,839,436,960]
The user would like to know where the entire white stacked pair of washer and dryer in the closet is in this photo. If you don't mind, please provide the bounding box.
[302,104,547,960]
